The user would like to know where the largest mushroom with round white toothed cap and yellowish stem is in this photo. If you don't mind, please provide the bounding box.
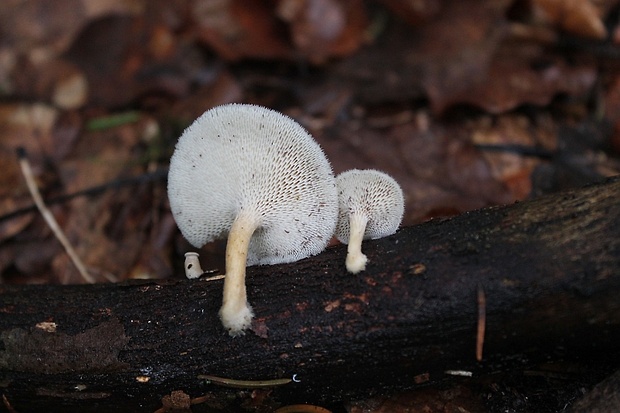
[168,104,338,336]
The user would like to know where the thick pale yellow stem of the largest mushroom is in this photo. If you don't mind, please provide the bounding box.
[220,210,258,337]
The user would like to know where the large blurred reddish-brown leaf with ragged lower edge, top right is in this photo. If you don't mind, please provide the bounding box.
[333,0,597,113]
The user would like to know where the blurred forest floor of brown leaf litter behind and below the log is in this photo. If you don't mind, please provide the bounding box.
[0,0,620,413]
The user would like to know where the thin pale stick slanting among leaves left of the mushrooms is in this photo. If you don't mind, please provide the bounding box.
[17,148,95,284]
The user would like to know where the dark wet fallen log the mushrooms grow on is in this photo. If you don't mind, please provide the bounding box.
[0,178,620,413]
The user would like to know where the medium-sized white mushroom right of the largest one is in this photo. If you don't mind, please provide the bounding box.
[336,169,405,274]
